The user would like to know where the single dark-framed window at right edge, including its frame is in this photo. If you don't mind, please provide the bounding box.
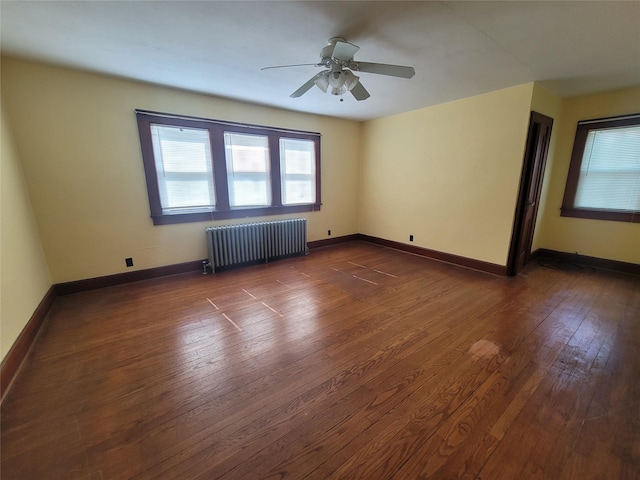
[561,114,640,223]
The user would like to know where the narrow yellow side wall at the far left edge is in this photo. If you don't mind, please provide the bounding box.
[0,104,51,359]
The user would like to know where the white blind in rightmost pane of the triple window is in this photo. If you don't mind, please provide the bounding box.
[280,138,316,205]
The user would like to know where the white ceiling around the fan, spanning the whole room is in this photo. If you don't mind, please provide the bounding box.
[0,0,640,120]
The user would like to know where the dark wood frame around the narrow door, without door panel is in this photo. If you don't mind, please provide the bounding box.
[507,111,553,276]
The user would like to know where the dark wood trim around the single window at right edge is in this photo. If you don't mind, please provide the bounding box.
[560,114,640,223]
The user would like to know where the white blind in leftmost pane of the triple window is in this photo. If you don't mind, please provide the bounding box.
[151,125,215,211]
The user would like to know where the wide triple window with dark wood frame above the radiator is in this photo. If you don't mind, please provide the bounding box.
[136,110,321,225]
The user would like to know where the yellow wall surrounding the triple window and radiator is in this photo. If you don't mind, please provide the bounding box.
[2,58,362,283]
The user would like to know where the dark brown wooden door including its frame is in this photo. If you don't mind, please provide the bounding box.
[507,112,553,275]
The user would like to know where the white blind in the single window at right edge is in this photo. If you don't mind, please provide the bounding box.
[574,126,640,211]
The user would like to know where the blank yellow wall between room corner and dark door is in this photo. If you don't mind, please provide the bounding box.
[360,84,533,265]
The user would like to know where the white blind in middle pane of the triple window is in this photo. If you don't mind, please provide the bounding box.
[224,132,271,207]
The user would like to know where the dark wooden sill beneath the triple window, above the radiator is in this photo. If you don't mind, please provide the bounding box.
[151,204,321,225]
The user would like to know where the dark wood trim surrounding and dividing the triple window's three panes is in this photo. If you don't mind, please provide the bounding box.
[135,110,322,225]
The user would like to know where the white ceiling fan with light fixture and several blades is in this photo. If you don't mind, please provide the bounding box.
[262,37,416,101]
